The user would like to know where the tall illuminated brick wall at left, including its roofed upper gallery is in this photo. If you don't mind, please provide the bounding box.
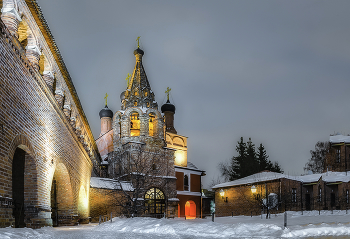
[0,0,98,228]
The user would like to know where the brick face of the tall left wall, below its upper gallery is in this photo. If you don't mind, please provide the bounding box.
[0,10,92,228]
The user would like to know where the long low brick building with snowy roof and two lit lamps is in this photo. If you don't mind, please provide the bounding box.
[212,171,350,216]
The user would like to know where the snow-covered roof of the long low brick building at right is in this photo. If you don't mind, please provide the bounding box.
[212,171,350,189]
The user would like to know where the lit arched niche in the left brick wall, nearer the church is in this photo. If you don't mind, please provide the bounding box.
[51,163,76,226]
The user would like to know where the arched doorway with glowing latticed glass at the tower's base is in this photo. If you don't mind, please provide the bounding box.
[145,188,165,218]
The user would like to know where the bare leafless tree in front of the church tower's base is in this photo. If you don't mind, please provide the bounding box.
[109,142,169,216]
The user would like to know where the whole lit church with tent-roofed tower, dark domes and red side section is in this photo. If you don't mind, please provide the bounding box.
[93,47,204,217]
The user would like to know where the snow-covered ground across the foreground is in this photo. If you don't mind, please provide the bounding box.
[0,211,350,239]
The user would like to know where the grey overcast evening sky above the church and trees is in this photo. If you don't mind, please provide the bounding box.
[37,0,350,187]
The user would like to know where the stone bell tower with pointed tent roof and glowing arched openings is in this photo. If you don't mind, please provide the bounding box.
[108,47,178,217]
